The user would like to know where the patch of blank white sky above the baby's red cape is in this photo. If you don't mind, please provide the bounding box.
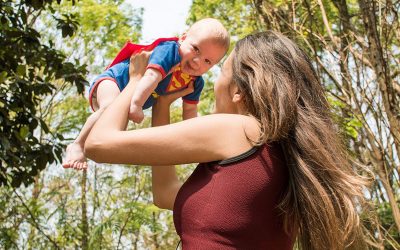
[126,0,192,43]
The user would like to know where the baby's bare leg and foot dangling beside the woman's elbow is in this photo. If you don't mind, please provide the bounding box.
[63,80,120,169]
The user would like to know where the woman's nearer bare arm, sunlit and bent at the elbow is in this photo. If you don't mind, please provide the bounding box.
[85,52,254,165]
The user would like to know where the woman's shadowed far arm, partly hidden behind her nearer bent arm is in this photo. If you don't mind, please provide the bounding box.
[152,84,193,210]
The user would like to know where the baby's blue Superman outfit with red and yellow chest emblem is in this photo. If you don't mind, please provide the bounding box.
[89,41,204,109]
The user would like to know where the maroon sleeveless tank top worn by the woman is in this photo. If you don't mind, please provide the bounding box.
[174,145,293,250]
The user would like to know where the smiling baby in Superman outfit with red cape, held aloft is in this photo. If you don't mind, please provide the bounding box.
[63,18,229,169]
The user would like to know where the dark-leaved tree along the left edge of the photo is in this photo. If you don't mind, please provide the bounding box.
[0,0,87,187]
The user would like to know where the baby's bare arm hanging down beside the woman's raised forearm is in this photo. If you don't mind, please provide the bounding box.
[129,68,162,123]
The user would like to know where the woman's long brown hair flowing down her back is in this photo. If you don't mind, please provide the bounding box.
[233,31,365,250]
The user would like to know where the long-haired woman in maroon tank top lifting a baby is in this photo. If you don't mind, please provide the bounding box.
[85,32,363,249]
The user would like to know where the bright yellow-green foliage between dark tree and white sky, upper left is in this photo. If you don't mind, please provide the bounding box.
[57,0,143,74]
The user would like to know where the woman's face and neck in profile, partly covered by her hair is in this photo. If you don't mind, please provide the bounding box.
[214,51,238,114]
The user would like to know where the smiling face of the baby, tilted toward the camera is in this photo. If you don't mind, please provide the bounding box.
[179,32,226,76]
